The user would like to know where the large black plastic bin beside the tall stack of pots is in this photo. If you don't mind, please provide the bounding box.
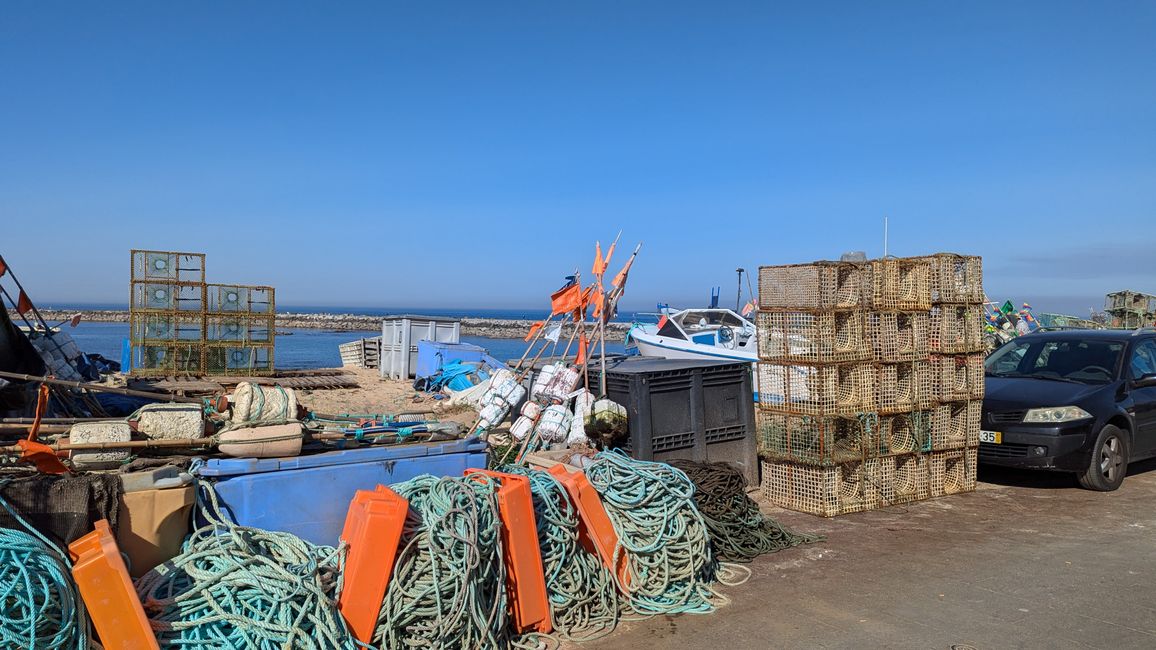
[590,356,758,486]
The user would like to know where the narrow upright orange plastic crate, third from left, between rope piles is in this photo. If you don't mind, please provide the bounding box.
[465,470,554,634]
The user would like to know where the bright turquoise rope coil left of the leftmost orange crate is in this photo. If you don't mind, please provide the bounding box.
[0,483,89,650]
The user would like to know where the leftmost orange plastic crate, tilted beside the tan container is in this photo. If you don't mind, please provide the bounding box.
[68,519,158,650]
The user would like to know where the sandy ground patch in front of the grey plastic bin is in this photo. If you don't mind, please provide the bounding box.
[297,368,476,427]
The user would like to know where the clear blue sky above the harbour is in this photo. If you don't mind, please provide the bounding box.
[0,0,1156,312]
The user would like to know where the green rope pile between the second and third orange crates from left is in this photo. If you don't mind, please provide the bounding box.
[373,474,510,649]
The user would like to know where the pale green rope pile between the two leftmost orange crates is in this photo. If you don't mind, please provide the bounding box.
[136,482,355,650]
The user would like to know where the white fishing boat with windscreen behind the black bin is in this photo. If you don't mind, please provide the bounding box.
[625,308,758,363]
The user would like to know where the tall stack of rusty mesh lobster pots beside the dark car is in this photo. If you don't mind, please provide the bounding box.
[757,253,984,517]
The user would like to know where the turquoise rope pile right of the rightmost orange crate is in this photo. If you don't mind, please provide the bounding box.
[586,451,721,615]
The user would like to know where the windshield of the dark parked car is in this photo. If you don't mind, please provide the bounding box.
[984,337,1124,384]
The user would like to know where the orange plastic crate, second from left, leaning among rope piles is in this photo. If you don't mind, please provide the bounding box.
[338,486,409,644]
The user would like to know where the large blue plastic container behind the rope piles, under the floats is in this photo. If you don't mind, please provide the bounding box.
[198,438,489,546]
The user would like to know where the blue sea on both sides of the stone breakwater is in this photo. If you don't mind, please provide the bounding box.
[47,303,635,370]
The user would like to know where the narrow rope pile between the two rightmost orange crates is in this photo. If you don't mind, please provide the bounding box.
[499,465,618,642]
